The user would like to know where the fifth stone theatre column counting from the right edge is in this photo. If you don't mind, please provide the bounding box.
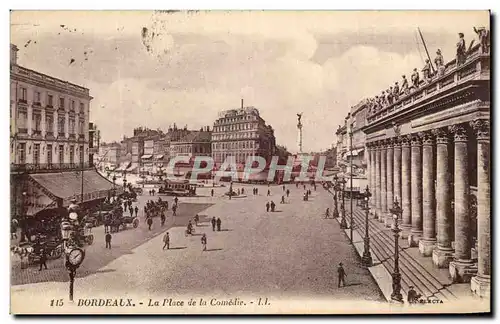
[408,134,422,246]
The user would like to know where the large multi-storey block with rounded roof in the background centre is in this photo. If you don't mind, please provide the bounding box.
[212,106,276,165]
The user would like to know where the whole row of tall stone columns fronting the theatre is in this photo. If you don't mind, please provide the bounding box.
[367,119,491,283]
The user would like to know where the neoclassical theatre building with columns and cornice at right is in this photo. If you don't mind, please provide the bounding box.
[364,45,491,296]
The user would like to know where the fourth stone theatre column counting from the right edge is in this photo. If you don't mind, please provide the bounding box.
[418,132,437,256]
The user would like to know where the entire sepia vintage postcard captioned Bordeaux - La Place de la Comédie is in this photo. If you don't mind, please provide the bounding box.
[10,10,492,314]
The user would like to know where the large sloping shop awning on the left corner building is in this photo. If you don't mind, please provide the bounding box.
[30,170,117,207]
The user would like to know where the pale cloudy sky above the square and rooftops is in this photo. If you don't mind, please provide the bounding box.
[11,11,489,152]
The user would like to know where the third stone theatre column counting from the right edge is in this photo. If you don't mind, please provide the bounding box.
[432,128,453,268]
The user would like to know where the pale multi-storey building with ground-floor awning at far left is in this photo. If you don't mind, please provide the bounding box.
[10,44,112,219]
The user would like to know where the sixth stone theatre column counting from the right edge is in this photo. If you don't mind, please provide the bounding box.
[401,136,411,238]
